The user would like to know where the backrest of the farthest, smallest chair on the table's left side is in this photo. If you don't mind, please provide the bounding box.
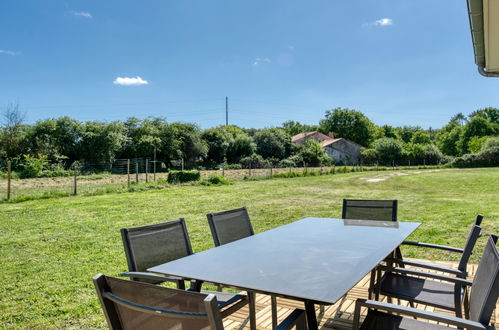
[206,207,255,246]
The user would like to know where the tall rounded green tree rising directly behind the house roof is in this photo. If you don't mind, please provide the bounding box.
[320,108,376,147]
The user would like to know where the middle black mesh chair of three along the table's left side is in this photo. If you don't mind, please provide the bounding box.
[120,218,248,322]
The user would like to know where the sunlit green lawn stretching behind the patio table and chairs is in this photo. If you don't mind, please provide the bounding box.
[0,168,499,329]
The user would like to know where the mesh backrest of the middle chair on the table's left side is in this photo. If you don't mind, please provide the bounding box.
[121,219,192,272]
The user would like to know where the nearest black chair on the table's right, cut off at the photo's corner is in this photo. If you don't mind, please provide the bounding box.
[353,235,499,330]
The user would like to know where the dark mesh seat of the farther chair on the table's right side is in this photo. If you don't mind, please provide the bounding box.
[380,272,455,310]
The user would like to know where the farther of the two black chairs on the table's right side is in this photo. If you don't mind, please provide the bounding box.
[375,225,481,317]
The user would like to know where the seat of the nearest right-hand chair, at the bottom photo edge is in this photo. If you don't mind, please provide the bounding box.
[360,310,449,330]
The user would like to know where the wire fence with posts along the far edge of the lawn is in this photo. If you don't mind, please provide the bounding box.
[0,158,442,200]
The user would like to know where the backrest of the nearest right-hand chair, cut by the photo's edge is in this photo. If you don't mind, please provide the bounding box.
[469,235,499,325]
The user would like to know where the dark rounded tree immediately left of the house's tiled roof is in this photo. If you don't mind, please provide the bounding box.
[253,128,291,159]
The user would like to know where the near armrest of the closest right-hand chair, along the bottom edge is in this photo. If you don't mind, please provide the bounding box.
[355,299,488,330]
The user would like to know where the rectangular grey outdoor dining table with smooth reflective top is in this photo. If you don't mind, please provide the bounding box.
[148,218,420,329]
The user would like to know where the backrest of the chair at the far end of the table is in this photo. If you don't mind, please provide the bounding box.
[341,199,397,221]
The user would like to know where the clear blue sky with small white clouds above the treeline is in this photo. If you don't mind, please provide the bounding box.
[0,0,499,128]
